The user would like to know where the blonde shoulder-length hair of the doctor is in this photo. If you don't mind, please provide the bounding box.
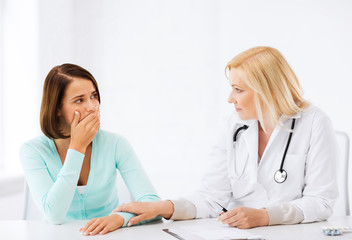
[225,47,309,131]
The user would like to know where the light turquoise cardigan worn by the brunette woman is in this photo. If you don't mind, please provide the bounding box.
[20,130,160,226]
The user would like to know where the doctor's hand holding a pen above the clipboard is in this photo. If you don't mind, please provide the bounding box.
[218,207,269,229]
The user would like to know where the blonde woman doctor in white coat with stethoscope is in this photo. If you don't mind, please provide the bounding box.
[111,47,338,228]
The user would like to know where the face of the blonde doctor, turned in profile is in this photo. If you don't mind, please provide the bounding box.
[228,68,258,120]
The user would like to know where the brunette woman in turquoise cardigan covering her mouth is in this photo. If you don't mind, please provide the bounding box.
[20,64,160,235]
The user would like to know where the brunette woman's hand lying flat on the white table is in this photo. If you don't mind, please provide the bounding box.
[80,214,125,236]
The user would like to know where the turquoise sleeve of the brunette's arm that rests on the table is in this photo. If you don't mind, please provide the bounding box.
[112,137,161,226]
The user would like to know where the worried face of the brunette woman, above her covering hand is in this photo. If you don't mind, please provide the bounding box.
[58,77,99,134]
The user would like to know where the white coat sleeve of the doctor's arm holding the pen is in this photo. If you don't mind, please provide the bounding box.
[266,111,338,225]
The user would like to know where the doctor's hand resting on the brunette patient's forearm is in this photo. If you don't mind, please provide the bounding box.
[113,201,174,227]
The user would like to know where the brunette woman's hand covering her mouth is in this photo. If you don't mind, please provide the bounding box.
[69,110,100,154]
